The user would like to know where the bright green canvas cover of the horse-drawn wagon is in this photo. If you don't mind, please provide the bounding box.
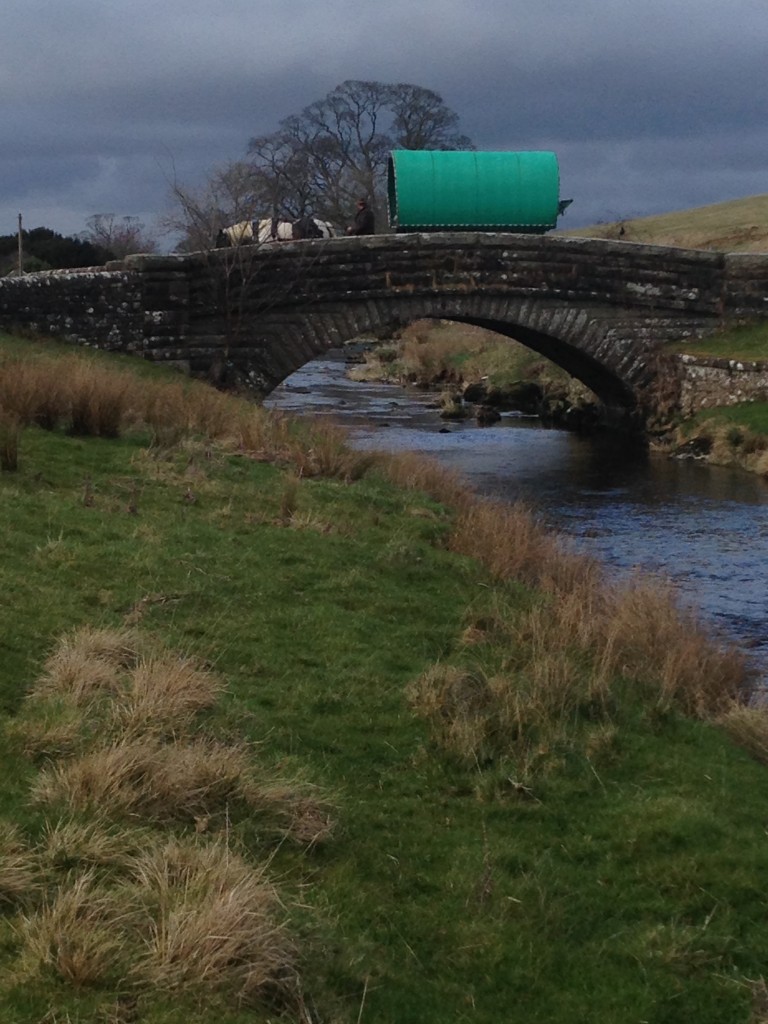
[387,150,560,232]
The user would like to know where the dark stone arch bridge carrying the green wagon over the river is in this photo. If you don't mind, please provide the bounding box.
[0,232,768,418]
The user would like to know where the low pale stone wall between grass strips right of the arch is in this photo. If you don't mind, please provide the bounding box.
[678,355,768,416]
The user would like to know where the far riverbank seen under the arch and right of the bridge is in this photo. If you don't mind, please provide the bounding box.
[348,321,768,476]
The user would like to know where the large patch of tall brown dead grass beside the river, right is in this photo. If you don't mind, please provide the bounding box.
[409,491,750,764]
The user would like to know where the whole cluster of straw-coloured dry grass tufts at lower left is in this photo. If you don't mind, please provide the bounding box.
[6,630,332,1013]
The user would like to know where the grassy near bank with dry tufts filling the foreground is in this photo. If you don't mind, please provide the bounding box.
[0,331,768,1024]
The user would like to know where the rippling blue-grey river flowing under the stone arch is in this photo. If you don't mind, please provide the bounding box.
[265,352,768,682]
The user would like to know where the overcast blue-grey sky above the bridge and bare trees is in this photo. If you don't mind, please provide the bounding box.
[0,0,768,242]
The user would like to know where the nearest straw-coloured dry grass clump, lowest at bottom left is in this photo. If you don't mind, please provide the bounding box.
[17,839,298,1007]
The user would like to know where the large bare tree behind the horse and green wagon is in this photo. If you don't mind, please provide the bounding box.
[165,80,474,251]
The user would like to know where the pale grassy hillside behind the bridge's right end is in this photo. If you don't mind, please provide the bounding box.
[557,195,768,253]
